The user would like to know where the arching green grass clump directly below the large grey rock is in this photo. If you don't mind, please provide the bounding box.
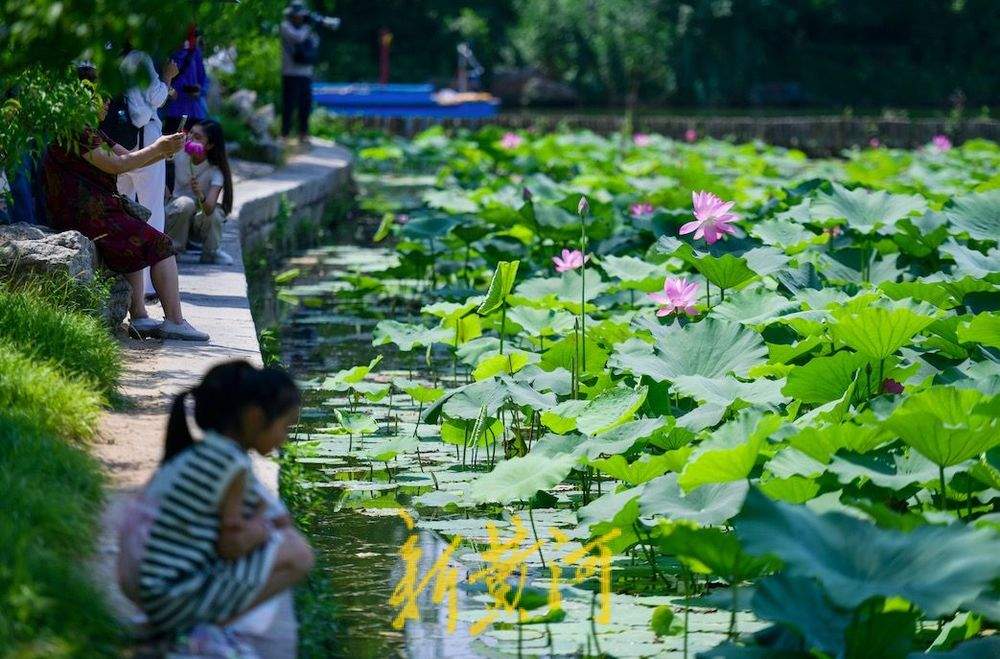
[0,287,121,393]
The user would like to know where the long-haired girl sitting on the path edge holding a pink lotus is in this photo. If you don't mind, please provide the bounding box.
[166,119,233,265]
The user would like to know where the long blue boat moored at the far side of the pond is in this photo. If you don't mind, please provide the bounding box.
[313,82,500,119]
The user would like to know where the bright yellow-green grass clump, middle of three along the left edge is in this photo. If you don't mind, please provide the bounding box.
[0,342,102,440]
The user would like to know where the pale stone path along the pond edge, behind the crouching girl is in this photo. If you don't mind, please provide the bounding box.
[93,142,350,657]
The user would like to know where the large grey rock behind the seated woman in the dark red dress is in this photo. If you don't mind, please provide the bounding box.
[0,224,98,281]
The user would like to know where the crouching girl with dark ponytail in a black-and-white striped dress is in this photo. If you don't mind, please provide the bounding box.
[119,361,313,648]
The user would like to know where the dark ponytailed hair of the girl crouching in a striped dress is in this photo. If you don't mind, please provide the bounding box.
[162,359,302,463]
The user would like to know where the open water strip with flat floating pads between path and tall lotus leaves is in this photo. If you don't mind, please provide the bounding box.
[262,176,761,658]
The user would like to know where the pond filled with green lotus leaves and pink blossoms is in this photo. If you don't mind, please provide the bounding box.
[268,128,1000,659]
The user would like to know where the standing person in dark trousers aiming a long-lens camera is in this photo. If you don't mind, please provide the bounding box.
[281,0,340,145]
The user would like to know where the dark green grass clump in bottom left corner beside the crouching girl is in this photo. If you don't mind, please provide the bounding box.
[0,416,118,657]
